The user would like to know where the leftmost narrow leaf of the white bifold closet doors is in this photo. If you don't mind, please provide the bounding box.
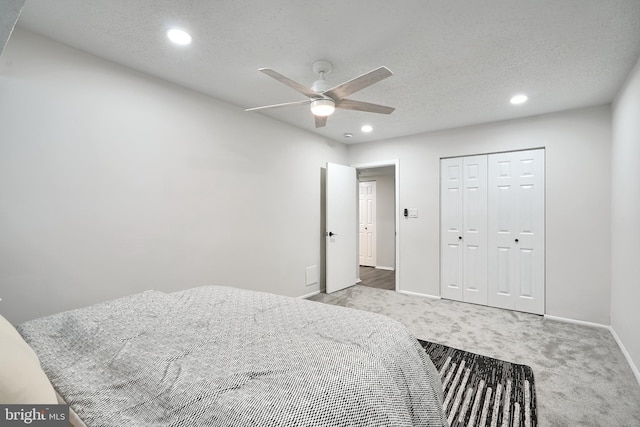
[440,158,463,301]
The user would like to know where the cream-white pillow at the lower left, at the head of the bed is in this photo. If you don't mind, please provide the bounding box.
[0,316,58,405]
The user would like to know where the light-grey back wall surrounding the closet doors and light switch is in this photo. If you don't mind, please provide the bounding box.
[349,106,611,325]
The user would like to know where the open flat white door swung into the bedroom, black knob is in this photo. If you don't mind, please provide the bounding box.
[325,163,358,293]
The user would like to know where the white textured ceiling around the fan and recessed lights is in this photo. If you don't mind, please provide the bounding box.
[13,0,640,143]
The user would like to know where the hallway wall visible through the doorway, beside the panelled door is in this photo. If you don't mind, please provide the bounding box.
[360,175,396,269]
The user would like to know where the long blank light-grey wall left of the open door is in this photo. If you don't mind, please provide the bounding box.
[0,29,346,322]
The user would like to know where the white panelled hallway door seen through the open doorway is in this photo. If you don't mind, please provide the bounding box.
[358,181,377,267]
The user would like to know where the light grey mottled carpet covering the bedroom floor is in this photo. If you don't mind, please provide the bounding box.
[310,285,640,427]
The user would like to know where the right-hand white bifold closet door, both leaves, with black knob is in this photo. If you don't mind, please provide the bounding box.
[488,149,545,314]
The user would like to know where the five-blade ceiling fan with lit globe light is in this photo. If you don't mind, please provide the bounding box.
[245,60,395,128]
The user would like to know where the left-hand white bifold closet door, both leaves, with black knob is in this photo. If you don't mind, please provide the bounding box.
[440,155,487,305]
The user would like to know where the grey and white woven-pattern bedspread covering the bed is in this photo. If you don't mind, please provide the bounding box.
[18,286,446,427]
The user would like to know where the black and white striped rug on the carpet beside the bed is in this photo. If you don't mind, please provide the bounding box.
[418,340,538,427]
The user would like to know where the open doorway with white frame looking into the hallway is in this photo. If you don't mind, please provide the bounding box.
[354,160,400,291]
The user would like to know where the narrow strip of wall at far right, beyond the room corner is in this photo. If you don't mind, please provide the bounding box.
[611,55,640,381]
